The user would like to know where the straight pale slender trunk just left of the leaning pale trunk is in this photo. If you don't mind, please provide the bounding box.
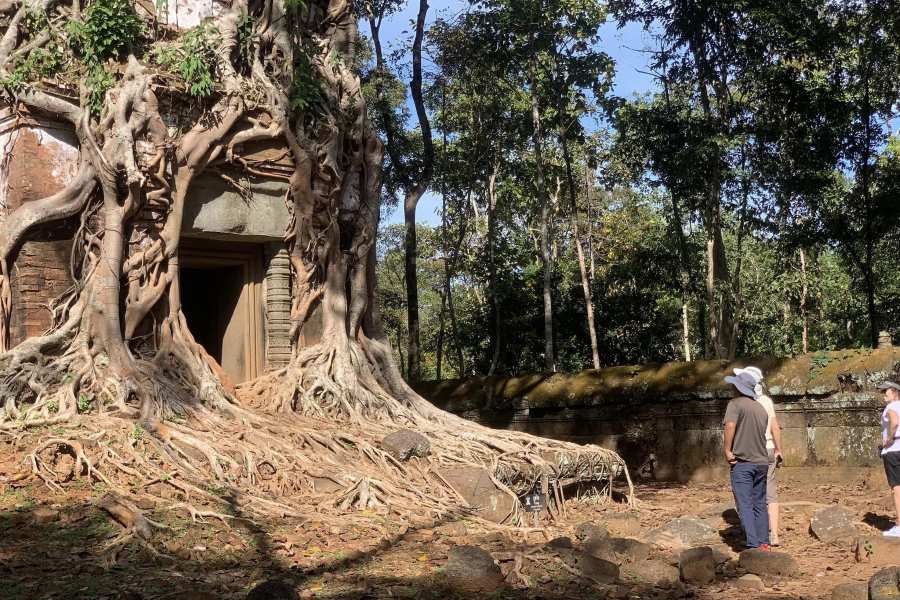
[529,57,556,372]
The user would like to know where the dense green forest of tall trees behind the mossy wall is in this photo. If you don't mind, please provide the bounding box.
[368,0,900,378]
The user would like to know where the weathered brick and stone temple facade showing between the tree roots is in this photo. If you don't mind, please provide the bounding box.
[0,67,296,383]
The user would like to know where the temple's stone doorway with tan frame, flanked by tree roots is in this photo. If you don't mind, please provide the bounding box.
[179,239,265,383]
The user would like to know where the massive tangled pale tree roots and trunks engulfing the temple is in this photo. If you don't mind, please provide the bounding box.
[0,0,630,536]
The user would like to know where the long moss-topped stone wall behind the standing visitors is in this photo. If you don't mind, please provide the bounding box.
[416,346,900,481]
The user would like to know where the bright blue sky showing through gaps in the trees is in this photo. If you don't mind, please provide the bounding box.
[360,0,654,225]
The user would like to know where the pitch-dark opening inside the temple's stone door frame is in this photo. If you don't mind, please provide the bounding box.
[179,264,246,364]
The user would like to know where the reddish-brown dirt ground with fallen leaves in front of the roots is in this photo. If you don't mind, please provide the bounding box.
[0,436,900,600]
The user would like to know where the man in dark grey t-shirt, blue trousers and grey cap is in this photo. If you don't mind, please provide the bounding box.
[724,369,769,548]
